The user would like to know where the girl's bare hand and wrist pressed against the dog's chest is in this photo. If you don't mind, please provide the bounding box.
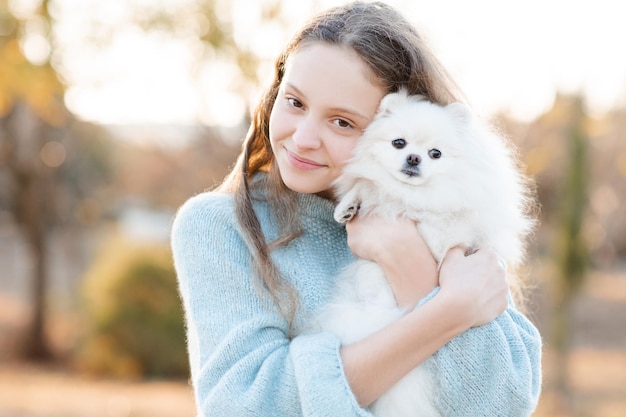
[346,215,438,307]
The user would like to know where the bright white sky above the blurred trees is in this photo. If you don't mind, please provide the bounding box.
[46,0,626,125]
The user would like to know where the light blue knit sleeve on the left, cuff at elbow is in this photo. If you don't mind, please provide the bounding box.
[172,195,371,417]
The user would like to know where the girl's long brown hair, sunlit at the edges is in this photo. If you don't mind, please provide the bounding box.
[218,2,460,333]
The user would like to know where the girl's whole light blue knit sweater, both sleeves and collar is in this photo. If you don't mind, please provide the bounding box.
[172,189,541,417]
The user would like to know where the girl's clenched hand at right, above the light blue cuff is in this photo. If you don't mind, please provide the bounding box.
[439,247,509,327]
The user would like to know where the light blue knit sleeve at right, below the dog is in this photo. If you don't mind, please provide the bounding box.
[420,288,542,417]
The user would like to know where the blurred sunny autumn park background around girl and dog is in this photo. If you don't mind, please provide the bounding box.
[0,0,626,417]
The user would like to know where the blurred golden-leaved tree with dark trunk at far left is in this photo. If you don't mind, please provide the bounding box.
[0,0,113,359]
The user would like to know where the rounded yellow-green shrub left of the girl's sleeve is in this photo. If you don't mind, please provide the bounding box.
[77,239,188,377]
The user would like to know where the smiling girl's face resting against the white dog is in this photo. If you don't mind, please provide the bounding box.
[269,42,386,196]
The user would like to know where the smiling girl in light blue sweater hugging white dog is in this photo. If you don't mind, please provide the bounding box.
[172,2,541,417]
